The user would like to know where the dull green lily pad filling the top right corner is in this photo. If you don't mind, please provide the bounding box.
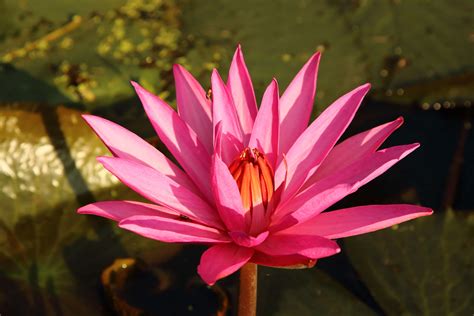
[341,0,474,105]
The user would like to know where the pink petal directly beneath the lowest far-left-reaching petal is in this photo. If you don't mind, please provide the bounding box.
[119,215,230,243]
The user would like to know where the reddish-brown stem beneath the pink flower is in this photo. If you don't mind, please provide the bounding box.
[238,263,257,316]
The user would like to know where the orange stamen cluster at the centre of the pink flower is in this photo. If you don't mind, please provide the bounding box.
[229,148,274,231]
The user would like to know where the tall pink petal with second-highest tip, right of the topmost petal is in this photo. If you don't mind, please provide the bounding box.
[279,53,321,154]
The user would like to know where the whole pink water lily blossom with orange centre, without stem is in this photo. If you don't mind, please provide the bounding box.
[78,46,432,284]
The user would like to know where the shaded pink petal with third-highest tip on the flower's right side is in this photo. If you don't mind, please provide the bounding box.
[304,117,403,188]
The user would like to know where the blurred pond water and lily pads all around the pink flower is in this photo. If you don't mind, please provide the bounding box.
[0,0,474,316]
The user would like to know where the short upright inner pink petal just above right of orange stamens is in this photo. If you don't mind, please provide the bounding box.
[249,79,279,170]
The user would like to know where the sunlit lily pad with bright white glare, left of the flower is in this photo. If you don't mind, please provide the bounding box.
[0,106,180,315]
